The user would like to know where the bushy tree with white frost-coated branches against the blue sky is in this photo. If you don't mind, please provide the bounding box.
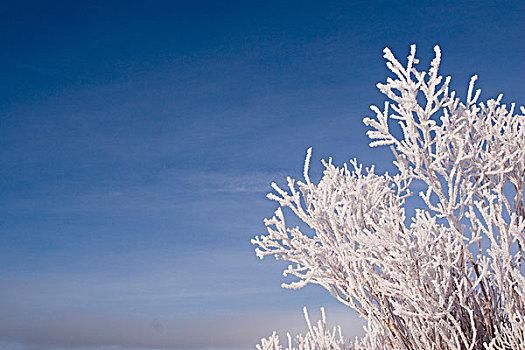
[252,46,525,350]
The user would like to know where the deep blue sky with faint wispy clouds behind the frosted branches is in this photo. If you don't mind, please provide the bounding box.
[0,1,525,350]
